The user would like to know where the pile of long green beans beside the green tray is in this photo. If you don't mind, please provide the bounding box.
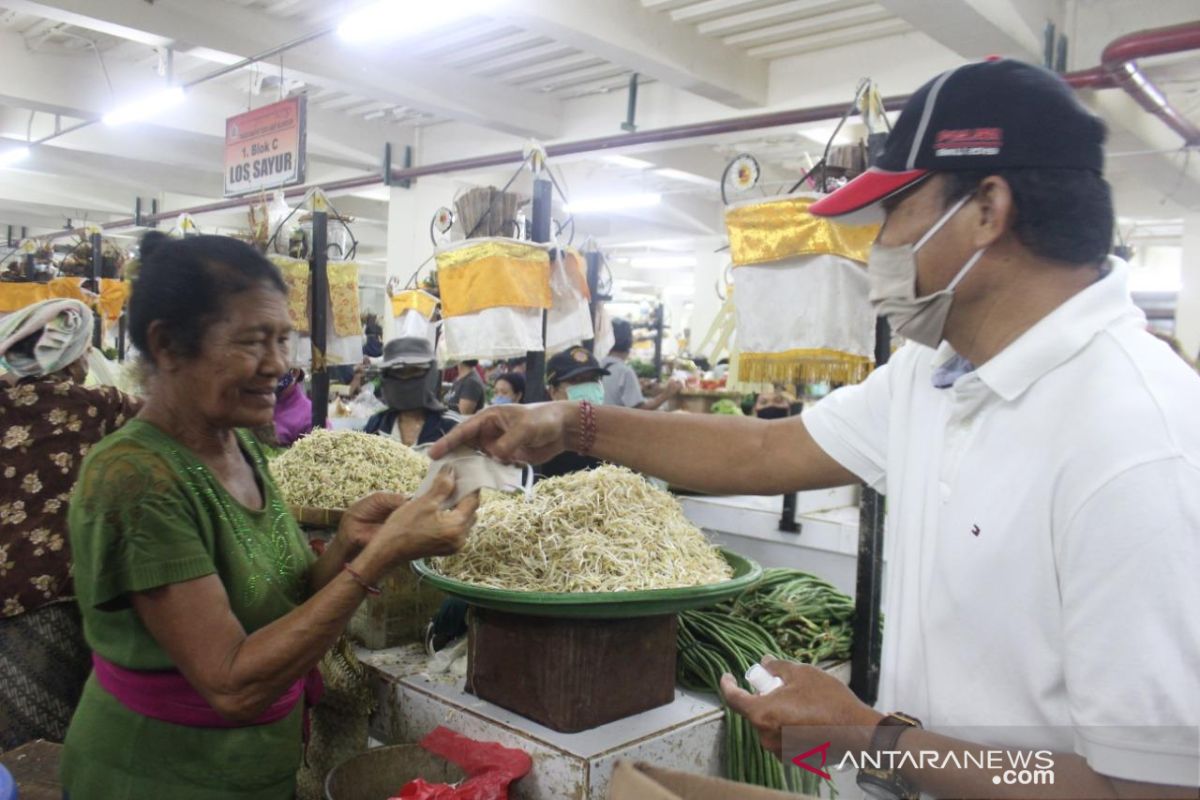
[678,570,854,796]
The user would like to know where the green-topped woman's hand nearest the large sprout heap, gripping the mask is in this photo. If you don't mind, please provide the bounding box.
[364,468,479,566]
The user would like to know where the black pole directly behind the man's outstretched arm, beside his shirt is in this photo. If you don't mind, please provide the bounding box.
[850,317,892,704]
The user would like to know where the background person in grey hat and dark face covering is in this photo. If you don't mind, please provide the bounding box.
[364,336,455,447]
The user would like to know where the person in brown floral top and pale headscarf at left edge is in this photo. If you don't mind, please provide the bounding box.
[0,300,140,751]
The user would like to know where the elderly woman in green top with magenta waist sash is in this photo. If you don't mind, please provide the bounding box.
[62,233,478,800]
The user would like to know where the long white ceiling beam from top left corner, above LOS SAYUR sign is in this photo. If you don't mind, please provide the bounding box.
[5,0,560,138]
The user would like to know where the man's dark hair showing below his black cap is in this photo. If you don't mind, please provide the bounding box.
[941,168,1115,264]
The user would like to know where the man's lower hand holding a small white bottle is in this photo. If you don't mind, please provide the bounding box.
[721,656,883,757]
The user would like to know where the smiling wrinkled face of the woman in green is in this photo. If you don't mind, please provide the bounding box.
[170,287,292,428]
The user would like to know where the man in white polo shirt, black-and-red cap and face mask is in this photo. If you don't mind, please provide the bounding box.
[432,60,1200,798]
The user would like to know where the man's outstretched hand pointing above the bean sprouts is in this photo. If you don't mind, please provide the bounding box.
[430,403,580,464]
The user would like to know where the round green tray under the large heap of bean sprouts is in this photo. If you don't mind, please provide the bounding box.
[413,548,762,619]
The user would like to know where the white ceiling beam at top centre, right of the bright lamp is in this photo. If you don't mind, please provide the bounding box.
[492,0,767,108]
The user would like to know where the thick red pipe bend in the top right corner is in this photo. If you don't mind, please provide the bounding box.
[1063,22,1200,146]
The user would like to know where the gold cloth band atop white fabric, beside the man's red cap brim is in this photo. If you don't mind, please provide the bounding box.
[725,197,880,266]
